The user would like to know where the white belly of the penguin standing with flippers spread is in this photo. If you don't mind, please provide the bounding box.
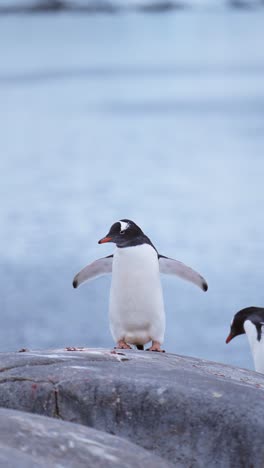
[109,244,165,344]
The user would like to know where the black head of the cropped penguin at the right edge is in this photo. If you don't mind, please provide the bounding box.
[226,307,264,343]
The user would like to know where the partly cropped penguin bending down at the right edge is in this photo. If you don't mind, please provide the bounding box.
[226,307,264,373]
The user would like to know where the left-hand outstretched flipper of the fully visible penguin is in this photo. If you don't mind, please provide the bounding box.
[72,255,113,288]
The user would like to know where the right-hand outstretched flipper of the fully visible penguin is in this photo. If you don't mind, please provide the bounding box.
[159,255,208,291]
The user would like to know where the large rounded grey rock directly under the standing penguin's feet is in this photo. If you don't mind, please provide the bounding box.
[0,349,264,468]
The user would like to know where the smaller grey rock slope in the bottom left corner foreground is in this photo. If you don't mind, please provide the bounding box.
[0,409,171,468]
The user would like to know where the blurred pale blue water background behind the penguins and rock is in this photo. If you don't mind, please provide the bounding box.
[0,0,264,368]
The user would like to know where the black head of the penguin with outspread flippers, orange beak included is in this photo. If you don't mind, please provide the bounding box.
[98,219,150,247]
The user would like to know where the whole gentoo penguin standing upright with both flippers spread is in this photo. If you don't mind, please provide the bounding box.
[73,219,208,352]
